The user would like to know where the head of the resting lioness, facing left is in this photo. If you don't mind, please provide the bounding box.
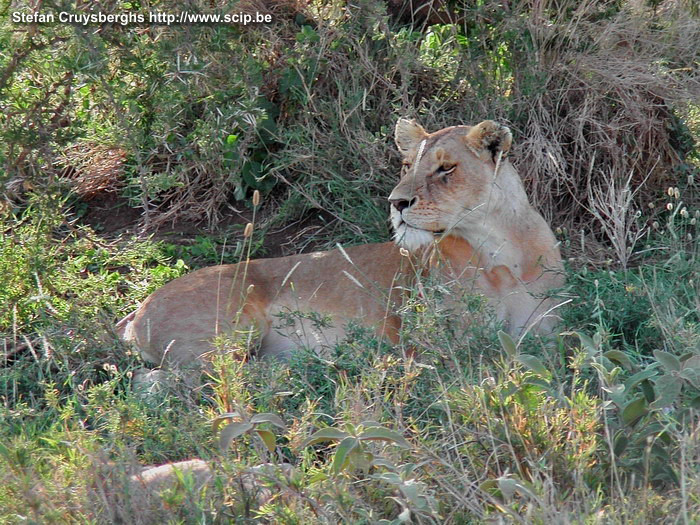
[389,119,522,250]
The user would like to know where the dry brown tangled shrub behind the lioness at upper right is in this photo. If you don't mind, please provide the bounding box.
[514,1,700,233]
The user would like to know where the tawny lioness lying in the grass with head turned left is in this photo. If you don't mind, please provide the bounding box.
[118,119,564,364]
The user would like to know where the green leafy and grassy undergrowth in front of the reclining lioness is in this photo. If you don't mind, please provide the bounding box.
[0,184,700,523]
